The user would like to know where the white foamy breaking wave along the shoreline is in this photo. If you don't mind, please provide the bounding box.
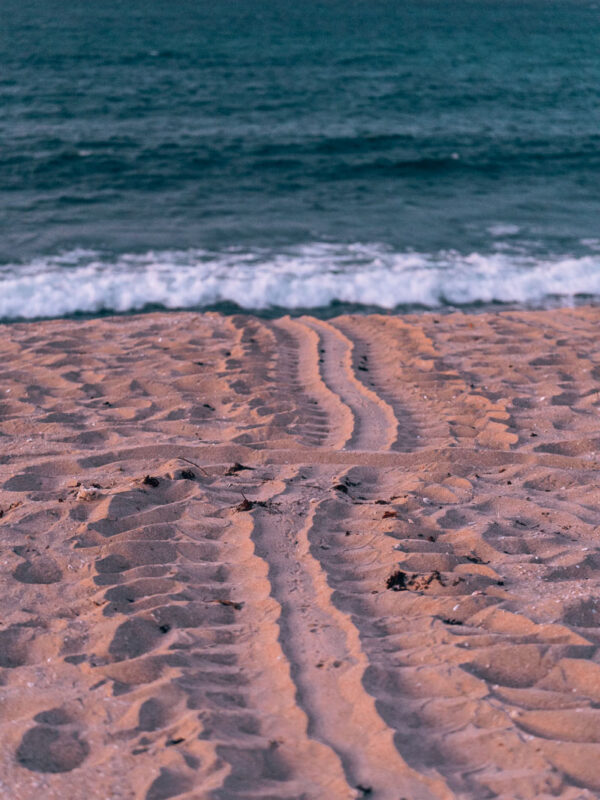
[0,244,600,320]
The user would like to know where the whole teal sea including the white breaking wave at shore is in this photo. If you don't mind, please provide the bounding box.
[0,0,600,320]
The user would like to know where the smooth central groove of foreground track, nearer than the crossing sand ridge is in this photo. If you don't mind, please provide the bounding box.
[246,470,447,800]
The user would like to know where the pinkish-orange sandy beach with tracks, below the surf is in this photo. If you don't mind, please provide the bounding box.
[0,309,600,800]
